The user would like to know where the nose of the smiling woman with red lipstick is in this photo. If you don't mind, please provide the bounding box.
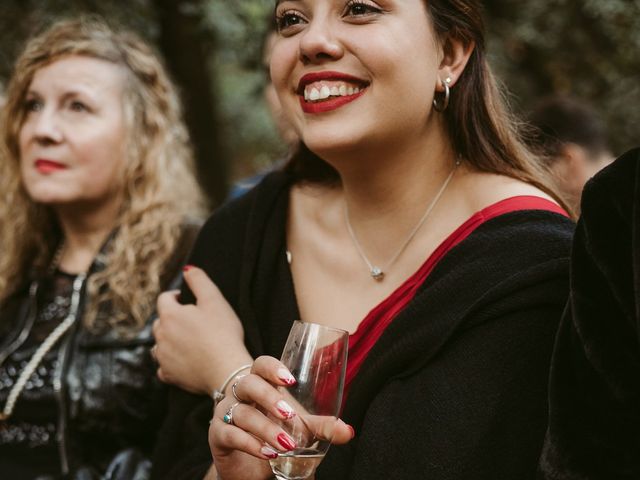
[300,17,344,65]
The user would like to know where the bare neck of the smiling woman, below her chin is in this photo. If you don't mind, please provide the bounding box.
[303,135,461,268]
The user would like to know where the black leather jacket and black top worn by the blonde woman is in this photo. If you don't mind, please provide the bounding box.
[0,225,197,480]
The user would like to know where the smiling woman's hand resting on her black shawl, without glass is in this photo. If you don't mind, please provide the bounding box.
[153,266,252,395]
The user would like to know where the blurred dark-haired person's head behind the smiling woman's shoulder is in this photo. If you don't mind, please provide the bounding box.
[529,96,613,212]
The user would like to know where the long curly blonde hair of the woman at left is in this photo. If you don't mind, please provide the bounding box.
[0,16,205,331]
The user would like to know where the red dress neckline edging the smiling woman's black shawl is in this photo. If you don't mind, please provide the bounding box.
[343,195,569,398]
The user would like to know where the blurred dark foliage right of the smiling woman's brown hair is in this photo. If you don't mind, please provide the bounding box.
[485,0,640,153]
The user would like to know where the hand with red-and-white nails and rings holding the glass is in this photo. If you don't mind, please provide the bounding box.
[209,357,353,480]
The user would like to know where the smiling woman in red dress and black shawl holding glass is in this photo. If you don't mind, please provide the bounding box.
[154,0,572,480]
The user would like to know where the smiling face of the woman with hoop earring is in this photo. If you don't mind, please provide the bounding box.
[271,0,442,155]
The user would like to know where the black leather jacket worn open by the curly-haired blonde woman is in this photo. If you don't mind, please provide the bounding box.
[0,226,197,480]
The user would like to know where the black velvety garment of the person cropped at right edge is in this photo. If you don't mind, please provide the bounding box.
[540,149,640,480]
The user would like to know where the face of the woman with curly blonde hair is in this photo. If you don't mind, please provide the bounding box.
[19,55,126,208]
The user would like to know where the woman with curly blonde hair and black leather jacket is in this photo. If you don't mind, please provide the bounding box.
[0,18,203,479]
